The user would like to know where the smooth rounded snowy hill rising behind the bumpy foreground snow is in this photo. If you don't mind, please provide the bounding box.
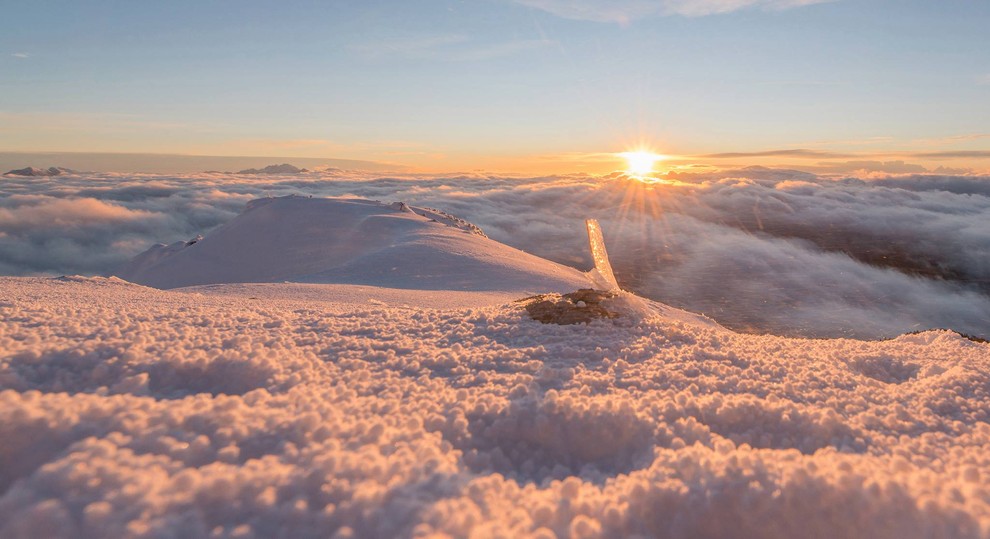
[116,197,590,292]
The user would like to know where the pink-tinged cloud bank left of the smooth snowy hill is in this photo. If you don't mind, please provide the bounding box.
[0,184,244,275]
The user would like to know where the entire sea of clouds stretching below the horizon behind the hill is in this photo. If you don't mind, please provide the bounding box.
[0,167,990,338]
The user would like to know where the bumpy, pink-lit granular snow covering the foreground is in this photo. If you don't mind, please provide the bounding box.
[0,278,990,537]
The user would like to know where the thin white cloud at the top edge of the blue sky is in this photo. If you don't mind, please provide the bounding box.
[514,0,831,24]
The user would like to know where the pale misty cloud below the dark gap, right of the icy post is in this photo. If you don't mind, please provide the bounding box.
[629,212,990,337]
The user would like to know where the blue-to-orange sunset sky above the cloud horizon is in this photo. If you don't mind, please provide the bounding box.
[0,0,990,173]
